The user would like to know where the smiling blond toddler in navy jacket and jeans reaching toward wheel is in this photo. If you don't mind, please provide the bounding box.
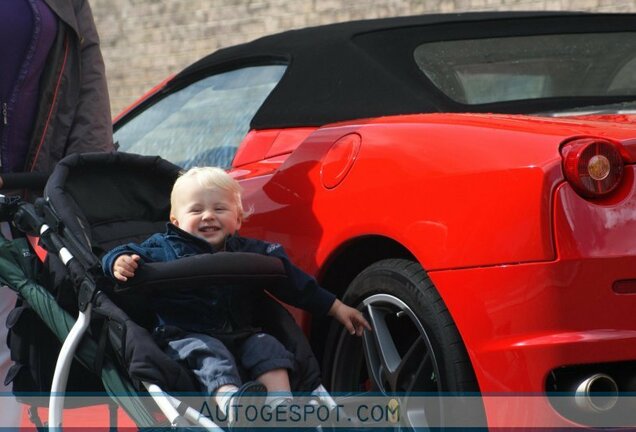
[102,167,371,422]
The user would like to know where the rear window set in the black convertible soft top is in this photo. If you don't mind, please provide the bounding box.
[414,32,636,105]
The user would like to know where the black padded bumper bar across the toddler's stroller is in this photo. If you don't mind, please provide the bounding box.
[115,252,287,293]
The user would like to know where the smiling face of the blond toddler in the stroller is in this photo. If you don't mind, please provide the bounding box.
[170,180,241,248]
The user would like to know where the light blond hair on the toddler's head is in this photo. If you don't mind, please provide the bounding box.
[170,167,252,219]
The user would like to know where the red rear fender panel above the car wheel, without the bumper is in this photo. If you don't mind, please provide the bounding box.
[236,115,629,273]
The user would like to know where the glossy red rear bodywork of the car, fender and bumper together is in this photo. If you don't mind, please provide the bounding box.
[226,114,636,424]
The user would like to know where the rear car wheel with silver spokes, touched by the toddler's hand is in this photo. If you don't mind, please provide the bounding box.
[325,259,478,427]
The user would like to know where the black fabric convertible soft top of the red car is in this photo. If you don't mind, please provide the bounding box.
[169,12,636,129]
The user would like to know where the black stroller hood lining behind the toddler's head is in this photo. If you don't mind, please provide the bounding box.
[44,152,180,256]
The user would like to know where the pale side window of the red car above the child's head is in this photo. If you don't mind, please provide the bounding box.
[114,65,287,169]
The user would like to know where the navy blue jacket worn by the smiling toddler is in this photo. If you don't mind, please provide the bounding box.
[102,223,336,331]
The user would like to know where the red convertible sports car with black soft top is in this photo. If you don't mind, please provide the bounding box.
[115,12,636,426]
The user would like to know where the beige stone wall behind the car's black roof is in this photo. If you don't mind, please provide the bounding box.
[89,0,636,115]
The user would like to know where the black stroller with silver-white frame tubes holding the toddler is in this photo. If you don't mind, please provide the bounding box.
[0,152,336,430]
